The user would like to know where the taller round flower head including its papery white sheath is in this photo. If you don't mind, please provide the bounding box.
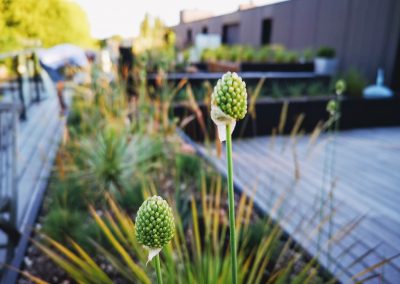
[211,72,247,141]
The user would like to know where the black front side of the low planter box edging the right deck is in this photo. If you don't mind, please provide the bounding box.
[174,97,400,141]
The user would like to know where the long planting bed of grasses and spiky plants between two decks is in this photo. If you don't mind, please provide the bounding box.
[19,62,334,283]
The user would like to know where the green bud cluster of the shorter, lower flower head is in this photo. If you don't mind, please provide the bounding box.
[136,196,175,249]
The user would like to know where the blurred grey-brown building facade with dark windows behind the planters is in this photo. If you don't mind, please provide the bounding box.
[173,0,400,90]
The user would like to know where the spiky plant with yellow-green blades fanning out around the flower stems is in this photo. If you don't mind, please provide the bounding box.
[25,184,336,284]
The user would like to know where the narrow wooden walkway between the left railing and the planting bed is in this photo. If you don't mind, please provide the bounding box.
[0,82,70,283]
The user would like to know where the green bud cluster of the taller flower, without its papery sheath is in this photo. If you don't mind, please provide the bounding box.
[212,72,247,120]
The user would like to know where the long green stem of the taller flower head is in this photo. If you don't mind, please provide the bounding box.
[226,124,237,284]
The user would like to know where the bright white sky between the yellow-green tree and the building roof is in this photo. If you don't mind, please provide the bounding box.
[75,0,279,38]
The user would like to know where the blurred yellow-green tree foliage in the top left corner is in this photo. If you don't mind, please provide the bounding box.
[0,0,91,52]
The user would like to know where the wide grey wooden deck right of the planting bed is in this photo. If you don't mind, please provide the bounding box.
[196,127,400,283]
